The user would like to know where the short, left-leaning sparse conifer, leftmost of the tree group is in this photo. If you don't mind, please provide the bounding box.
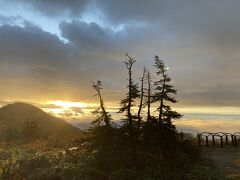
[92,80,112,127]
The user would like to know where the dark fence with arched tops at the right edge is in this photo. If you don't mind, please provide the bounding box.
[197,132,240,148]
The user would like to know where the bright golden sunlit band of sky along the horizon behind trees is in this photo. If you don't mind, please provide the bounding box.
[36,100,240,133]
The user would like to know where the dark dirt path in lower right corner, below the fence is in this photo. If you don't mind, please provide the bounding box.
[203,147,240,179]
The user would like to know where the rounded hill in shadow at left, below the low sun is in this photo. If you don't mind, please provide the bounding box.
[0,103,83,144]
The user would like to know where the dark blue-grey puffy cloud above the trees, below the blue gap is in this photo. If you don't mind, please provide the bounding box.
[59,20,166,60]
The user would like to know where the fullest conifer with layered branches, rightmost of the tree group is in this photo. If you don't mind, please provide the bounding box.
[154,56,182,128]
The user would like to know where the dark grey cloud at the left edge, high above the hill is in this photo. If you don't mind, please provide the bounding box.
[0,25,70,75]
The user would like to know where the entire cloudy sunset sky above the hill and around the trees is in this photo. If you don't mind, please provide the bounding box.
[0,0,240,132]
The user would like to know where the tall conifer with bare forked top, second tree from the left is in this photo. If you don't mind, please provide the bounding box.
[119,54,139,136]
